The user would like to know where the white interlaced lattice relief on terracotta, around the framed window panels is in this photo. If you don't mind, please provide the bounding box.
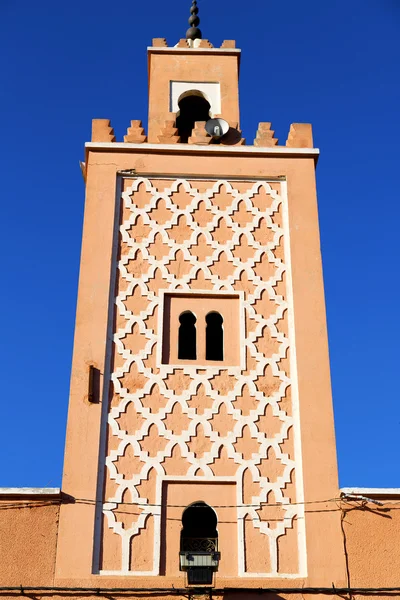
[101,177,305,577]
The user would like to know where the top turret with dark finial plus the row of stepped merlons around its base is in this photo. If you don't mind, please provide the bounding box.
[90,0,313,149]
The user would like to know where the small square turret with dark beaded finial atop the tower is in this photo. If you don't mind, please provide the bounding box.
[148,0,239,144]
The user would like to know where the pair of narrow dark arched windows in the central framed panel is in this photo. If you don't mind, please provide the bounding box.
[178,311,224,361]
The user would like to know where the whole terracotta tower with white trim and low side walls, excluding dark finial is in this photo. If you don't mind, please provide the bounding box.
[0,32,400,598]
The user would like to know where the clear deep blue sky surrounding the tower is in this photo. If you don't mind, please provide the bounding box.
[0,0,400,487]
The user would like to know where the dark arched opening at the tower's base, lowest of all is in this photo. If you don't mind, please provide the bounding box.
[181,502,218,552]
